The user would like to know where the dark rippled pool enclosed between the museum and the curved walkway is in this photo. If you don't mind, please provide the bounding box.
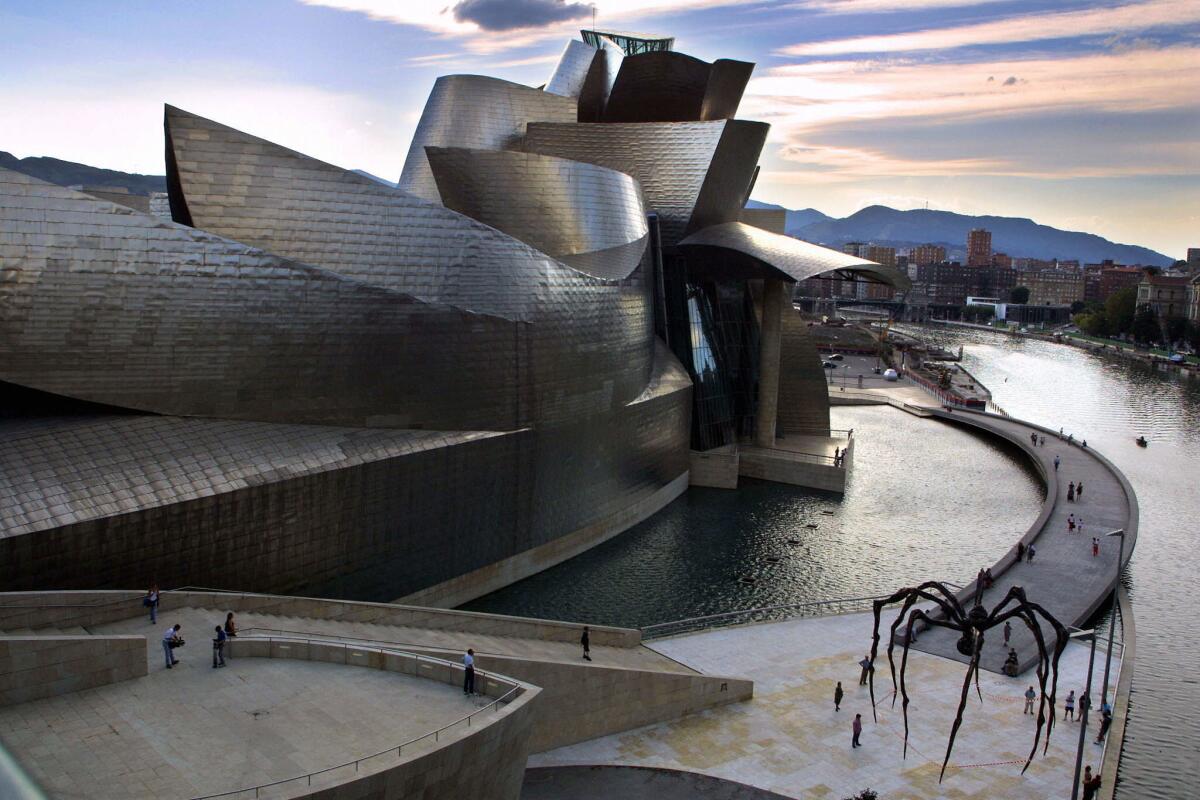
[467,407,1042,626]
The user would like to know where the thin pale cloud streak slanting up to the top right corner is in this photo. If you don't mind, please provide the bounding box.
[780,0,1200,56]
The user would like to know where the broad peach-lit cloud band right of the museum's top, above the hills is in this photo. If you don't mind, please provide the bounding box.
[742,46,1200,182]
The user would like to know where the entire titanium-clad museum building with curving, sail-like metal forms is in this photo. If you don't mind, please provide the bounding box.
[0,31,907,604]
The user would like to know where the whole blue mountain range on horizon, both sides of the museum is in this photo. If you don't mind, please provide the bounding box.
[0,151,1174,266]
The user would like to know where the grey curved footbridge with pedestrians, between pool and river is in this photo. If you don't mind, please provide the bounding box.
[913,408,1138,672]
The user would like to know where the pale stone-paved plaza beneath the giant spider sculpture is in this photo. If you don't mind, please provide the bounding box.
[529,614,1118,800]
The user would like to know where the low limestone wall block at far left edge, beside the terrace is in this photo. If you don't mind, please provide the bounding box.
[0,636,146,706]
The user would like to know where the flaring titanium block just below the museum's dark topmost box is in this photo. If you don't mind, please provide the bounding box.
[521,120,768,247]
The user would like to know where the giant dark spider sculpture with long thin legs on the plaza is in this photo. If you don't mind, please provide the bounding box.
[869,575,1069,782]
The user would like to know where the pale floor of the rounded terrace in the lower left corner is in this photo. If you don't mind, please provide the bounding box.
[0,610,478,800]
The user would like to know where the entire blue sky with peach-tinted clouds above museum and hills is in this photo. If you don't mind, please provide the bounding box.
[0,0,1200,258]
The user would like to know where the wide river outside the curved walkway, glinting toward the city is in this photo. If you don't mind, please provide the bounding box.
[902,331,1200,800]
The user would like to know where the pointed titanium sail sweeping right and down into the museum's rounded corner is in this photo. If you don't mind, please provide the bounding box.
[167,108,653,419]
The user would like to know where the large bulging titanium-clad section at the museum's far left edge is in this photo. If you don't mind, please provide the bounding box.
[0,170,525,431]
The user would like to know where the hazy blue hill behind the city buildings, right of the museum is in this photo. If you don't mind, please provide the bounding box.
[753,205,1174,266]
